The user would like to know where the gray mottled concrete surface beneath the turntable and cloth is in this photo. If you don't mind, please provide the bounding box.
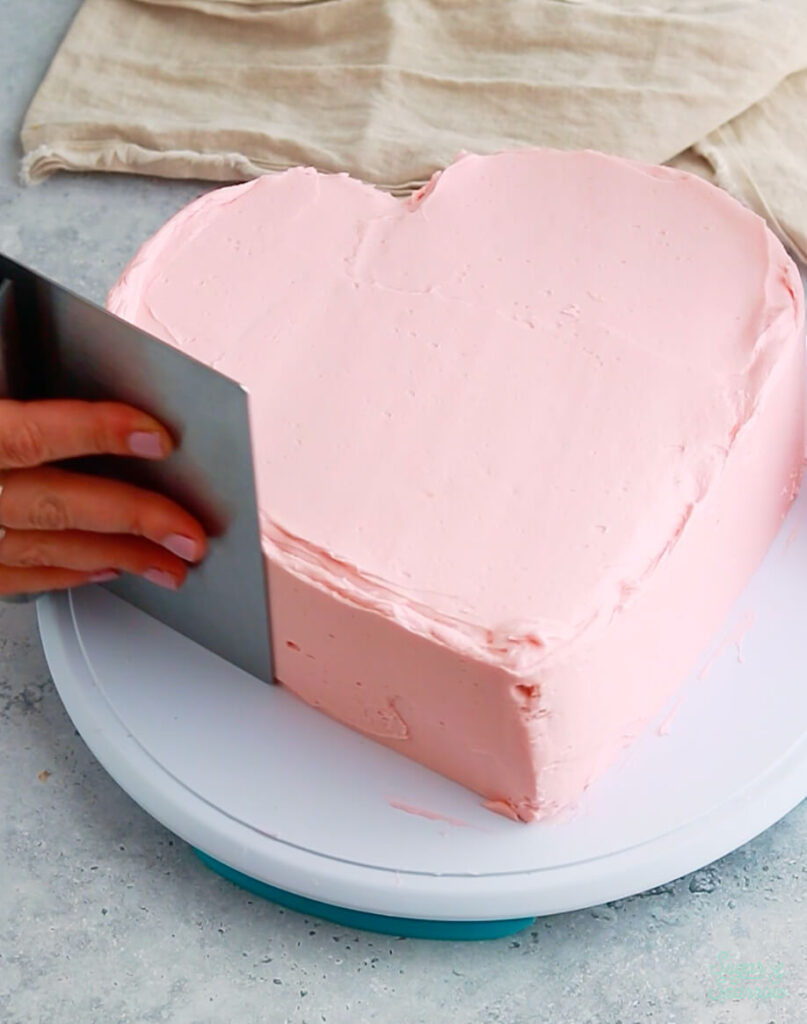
[0,0,807,1024]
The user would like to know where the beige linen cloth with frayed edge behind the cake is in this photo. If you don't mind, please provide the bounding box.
[23,0,807,259]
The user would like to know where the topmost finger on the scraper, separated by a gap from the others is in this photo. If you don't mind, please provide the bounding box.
[0,398,173,469]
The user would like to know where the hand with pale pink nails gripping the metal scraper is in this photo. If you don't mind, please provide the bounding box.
[0,399,206,596]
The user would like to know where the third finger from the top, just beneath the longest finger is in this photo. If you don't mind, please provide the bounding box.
[0,528,187,590]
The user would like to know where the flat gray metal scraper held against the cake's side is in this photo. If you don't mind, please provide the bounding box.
[0,254,272,682]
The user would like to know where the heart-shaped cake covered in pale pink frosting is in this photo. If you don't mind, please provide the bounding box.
[110,151,805,820]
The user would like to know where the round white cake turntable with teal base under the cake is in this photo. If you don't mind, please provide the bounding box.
[38,487,807,939]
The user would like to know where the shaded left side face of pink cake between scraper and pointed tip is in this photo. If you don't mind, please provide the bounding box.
[267,560,537,806]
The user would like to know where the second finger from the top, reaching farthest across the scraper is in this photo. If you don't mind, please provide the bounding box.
[0,466,207,562]
